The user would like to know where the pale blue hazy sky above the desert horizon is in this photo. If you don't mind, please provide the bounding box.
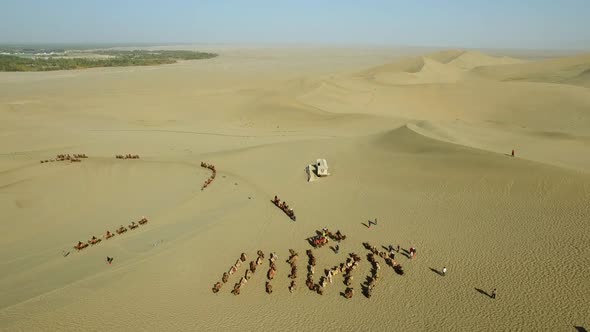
[0,0,590,49]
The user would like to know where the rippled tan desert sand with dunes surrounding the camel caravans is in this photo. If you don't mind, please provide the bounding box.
[0,45,590,331]
